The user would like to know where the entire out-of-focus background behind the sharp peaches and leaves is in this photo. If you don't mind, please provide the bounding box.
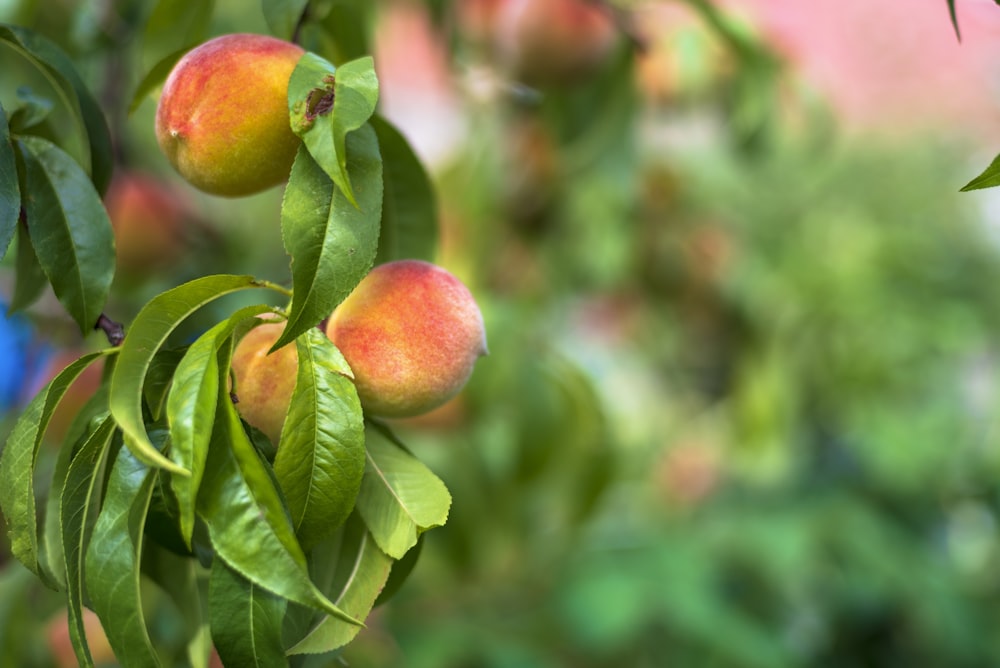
[0,0,1000,668]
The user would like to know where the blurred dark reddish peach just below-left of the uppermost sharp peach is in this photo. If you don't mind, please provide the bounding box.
[104,172,188,279]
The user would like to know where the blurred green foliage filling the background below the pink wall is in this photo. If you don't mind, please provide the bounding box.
[0,0,1000,668]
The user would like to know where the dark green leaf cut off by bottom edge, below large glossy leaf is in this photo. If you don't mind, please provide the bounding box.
[208,559,288,668]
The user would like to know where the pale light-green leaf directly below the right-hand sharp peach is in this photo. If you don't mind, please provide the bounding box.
[357,425,451,559]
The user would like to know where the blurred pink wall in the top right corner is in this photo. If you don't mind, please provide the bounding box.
[724,0,1000,138]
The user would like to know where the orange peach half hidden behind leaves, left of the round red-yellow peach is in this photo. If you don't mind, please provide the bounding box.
[232,322,299,445]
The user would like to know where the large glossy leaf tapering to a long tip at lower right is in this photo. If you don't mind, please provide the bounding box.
[198,393,360,624]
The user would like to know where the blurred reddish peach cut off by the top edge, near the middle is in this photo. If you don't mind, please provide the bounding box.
[497,0,618,85]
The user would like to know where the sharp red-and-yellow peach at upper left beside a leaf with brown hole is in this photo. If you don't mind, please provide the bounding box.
[156,34,304,197]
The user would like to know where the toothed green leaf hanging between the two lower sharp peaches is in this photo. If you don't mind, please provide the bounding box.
[274,327,365,546]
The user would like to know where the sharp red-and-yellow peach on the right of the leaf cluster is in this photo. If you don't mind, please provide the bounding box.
[326,260,486,417]
